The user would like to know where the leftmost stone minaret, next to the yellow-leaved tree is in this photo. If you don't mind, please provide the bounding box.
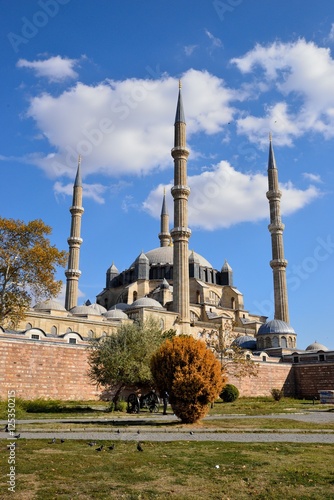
[65,156,84,311]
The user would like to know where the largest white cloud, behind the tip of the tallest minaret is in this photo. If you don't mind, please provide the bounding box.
[27,70,237,177]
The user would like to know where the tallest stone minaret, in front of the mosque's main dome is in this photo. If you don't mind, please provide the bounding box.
[171,83,191,333]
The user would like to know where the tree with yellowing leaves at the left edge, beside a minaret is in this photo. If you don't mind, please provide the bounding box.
[0,217,67,327]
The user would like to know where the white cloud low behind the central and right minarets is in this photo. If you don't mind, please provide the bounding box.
[144,161,320,230]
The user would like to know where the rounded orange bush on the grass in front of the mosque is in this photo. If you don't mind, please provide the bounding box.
[151,336,226,423]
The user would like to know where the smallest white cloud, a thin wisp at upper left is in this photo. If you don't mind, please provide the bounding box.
[16,56,78,82]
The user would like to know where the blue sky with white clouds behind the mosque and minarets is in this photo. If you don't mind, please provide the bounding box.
[0,0,334,348]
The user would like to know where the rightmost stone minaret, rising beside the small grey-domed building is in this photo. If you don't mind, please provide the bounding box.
[267,134,289,324]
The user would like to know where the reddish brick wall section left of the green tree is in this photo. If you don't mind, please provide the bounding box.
[0,339,100,401]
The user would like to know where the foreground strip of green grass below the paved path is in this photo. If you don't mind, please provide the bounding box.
[0,440,334,500]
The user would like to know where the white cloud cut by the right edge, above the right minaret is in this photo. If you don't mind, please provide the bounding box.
[231,39,334,145]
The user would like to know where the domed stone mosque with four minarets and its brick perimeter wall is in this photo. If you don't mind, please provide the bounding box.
[0,86,334,399]
